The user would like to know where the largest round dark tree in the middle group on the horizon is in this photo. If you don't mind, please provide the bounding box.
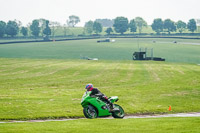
[113,17,129,34]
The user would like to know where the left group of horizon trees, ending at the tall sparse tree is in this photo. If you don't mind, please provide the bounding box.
[0,15,80,39]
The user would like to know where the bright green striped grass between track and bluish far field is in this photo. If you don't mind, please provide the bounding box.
[0,58,200,120]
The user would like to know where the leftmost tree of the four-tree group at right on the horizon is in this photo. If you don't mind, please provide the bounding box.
[151,18,163,34]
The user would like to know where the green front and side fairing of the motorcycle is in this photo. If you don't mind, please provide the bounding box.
[81,91,111,116]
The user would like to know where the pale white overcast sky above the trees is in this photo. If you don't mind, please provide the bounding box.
[0,0,200,26]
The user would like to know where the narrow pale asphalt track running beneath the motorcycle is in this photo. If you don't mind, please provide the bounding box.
[0,112,200,124]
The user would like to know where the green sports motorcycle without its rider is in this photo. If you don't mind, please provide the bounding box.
[81,91,124,119]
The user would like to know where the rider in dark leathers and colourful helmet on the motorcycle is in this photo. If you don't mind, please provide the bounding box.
[85,84,114,111]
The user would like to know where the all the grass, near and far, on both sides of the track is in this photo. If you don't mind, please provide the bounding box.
[0,38,200,133]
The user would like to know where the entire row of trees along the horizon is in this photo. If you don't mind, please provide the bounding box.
[0,15,197,39]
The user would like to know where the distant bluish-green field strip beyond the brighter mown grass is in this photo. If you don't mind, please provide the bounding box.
[0,38,200,64]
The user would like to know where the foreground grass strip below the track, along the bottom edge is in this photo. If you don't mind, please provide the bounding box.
[0,117,200,133]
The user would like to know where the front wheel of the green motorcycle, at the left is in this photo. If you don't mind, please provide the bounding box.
[83,105,97,119]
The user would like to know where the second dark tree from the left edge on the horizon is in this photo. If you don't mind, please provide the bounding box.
[6,21,19,37]
